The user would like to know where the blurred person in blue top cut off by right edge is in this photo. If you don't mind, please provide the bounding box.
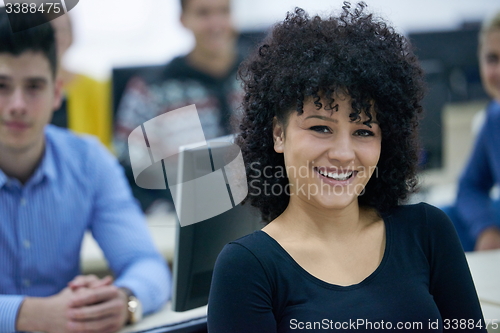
[444,12,500,251]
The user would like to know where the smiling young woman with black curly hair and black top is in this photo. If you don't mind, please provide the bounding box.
[208,4,486,333]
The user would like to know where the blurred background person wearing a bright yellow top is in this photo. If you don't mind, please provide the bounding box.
[51,14,112,149]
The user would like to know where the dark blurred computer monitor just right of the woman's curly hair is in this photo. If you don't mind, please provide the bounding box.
[409,24,488,169]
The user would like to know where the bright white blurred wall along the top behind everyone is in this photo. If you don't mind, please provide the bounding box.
[19,0,500,77]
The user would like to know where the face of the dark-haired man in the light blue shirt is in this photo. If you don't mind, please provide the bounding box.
[0,51,61,153]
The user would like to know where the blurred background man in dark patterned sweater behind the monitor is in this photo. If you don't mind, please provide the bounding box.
[114,0,242,210]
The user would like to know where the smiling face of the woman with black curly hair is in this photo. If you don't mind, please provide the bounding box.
[273,95,382,209]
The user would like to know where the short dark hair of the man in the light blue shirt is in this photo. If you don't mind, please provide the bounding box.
[0,8,57,77]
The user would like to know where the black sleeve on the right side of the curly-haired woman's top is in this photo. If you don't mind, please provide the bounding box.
[426,205,486,332]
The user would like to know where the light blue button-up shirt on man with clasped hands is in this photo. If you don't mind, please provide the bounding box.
[0,125,171,333]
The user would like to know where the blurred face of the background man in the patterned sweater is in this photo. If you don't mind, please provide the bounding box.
[181,0,236,53]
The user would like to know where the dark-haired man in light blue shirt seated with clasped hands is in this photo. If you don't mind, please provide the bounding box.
[0,8,170,333]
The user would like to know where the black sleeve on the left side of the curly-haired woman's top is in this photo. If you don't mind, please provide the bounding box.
[208,243,277,333]
